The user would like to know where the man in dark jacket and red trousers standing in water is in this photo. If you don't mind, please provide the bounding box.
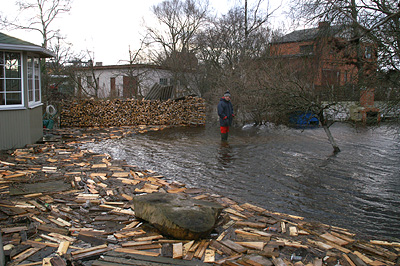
[218,91,235,141]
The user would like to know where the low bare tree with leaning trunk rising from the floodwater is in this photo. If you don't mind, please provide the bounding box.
[264,59,343,153]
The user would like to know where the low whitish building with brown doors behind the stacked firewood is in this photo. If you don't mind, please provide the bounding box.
[74,63,195,99]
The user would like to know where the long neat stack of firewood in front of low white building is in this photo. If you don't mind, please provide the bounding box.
[60,96,205,127]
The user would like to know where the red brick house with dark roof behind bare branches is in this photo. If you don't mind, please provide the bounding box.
[270,22,377,100]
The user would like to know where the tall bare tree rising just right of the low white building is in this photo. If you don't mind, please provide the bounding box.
[147,0,209,96]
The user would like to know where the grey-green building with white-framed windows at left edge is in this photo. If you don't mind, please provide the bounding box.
[0,33,54,150]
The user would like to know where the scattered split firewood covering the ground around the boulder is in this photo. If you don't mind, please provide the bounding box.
[0,127,400,266]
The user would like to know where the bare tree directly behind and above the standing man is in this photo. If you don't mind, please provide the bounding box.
[197,0,272,124]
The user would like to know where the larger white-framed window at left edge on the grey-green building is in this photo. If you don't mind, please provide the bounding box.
[0,50,25,110]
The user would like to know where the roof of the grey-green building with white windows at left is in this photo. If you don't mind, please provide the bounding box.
[0,32,54,57]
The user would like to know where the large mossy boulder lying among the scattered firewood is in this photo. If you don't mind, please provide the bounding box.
[133,193,223,239]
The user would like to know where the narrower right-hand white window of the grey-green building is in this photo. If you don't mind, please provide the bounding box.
[28,57,41,105]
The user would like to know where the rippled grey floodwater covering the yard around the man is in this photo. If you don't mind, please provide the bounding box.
[83,123,400,241]
